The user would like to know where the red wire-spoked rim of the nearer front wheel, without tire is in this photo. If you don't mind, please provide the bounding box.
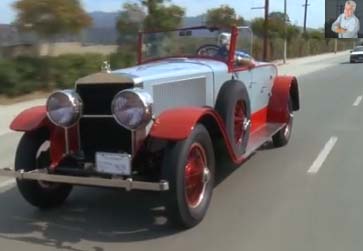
[185,143,209,208]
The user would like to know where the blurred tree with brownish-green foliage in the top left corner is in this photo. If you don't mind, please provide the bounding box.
[13,0,92,54]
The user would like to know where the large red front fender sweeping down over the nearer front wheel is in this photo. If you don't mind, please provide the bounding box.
[149,107,245,164]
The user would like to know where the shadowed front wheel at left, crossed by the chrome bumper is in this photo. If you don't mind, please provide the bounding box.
[15,130,72,208]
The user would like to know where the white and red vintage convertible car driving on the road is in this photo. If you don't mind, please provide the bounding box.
[0,27,300,228]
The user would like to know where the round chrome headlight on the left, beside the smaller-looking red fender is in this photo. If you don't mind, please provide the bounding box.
[47,90,82,128]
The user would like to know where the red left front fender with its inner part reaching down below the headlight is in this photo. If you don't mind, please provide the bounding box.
[10,106,79,167]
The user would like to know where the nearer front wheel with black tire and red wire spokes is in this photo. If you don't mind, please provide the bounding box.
[162,125,215,228]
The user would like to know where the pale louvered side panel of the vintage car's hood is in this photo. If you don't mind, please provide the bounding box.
[153,77,206,115]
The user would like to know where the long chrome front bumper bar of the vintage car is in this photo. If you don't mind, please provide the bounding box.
[0,168,169,191]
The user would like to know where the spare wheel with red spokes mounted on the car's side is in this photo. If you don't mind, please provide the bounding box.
[215,80,251,156]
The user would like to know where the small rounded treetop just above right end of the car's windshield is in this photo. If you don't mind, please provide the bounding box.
[206,5,245,27]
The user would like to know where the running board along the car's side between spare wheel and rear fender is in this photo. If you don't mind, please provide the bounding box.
[244,123,286,158]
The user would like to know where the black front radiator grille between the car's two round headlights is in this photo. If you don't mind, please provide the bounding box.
[76,84,133,162]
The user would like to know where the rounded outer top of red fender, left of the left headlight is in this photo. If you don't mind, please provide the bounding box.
[10,106,50,132]
